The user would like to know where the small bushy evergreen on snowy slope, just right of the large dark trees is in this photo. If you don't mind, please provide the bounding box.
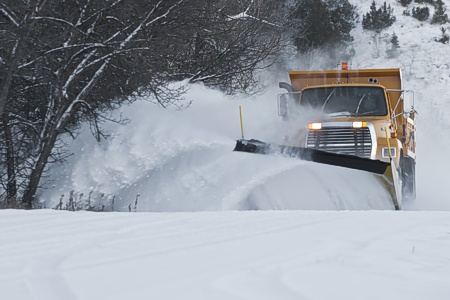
[362,1,396,32]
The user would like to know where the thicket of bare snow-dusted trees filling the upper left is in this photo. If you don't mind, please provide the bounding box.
[0,0,281,208]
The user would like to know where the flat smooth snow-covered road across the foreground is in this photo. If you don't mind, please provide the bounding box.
[0,210,450,300]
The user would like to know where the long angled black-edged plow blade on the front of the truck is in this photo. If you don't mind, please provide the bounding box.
[233,139,401,210]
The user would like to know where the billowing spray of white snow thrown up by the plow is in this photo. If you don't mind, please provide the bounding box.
[45,85,392,211]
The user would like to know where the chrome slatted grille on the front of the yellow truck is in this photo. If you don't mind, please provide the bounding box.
[307,127,372,158]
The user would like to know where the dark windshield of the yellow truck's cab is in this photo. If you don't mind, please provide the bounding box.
[300,86,387,116]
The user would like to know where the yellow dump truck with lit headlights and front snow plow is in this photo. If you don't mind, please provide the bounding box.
[234,63,417,210]
